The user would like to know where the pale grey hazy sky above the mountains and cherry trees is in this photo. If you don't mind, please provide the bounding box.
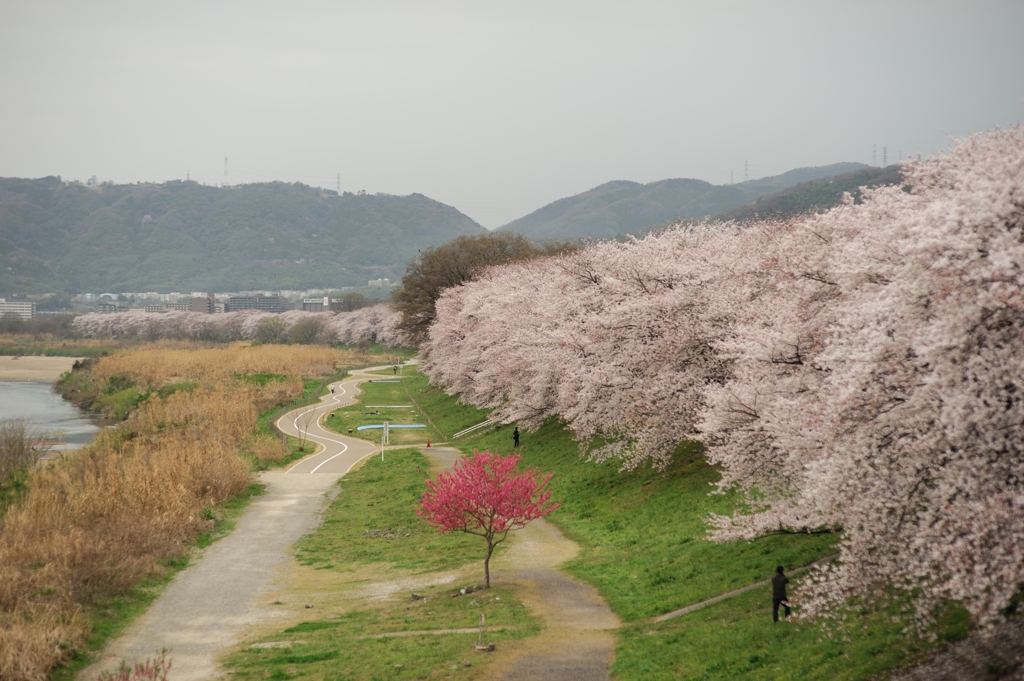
[0,0,1024,227]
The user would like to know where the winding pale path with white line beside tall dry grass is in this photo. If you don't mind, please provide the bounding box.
[79,367,387,681]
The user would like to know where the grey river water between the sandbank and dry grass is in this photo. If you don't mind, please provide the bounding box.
[0,381,100,450]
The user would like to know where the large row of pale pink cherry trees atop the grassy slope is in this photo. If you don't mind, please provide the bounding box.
[424,127,1024,621]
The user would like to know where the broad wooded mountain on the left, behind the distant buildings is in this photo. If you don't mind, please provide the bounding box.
[0,177,486,293]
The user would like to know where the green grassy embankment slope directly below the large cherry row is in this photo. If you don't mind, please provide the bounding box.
[411,386,969,680]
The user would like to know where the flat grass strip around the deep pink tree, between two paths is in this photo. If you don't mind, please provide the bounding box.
[226,450,540,680]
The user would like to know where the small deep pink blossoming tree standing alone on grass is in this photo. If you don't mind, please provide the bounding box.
[417,451,559,589]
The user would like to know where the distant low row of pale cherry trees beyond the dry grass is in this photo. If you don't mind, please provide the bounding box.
[74,304,400,346]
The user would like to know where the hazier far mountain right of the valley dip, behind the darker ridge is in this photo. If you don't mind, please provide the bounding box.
[501,163,866,239]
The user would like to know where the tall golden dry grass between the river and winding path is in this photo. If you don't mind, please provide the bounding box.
[0,347,356,681]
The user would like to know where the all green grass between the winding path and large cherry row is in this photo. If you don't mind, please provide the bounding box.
[228,358,969,681]
